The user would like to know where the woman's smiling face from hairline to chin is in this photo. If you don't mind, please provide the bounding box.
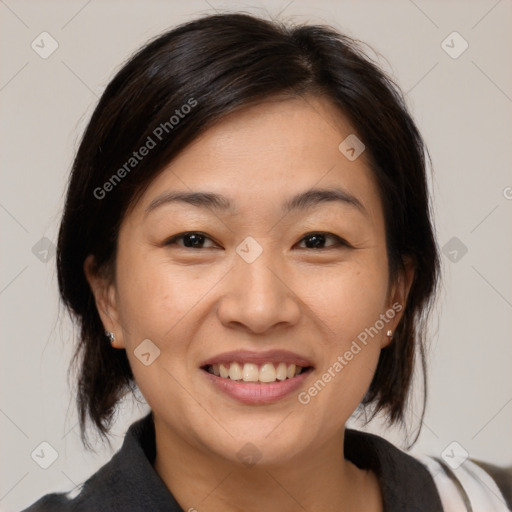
[91,98,404,464]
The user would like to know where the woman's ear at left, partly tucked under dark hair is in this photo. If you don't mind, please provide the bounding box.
[84,254,125,348]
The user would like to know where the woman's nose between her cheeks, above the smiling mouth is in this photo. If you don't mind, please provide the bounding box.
[217,251,300,334]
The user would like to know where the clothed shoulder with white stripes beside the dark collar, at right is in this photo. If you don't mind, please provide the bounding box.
[344,429,512,512]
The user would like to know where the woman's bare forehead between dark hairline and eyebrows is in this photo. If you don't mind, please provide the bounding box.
[132,97,379,222]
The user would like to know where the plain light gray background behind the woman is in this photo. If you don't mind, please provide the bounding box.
[0,0,512,510]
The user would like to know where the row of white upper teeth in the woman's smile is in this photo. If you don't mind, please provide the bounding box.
[208,362,302,382]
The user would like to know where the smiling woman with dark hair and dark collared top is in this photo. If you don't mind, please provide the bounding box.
[23,14,510,512]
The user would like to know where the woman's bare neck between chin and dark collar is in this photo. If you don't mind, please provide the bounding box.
[154,424,383,512]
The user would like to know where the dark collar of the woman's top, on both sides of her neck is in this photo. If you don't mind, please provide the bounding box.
[76,413,443,512]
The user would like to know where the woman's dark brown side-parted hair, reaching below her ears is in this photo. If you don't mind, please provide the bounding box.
[57,10,439,444]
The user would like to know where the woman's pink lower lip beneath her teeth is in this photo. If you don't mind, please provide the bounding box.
[201,369,312,405]
